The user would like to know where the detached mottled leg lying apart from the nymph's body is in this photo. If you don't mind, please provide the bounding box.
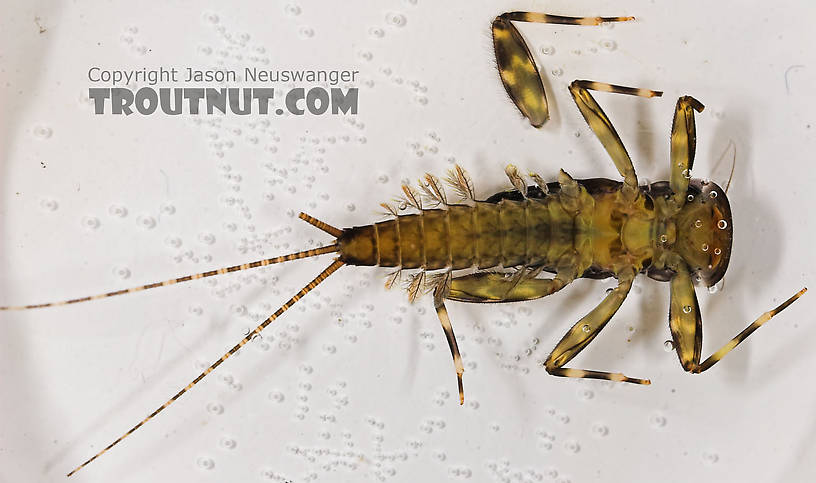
[492,12,634,127]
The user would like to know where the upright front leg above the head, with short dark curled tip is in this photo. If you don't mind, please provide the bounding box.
[669,96,704,211]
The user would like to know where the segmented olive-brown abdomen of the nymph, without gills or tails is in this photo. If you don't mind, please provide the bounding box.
[338,196,576,270]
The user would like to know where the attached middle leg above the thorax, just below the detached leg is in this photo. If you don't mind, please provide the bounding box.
[569,80,663,199]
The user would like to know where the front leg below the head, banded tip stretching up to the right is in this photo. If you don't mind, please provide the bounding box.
[669,267,807,374]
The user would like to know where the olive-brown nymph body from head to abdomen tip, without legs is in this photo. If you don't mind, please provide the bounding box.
[338,179,731,284]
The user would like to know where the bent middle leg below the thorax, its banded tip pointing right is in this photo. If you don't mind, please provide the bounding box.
[544,270,651,384]
